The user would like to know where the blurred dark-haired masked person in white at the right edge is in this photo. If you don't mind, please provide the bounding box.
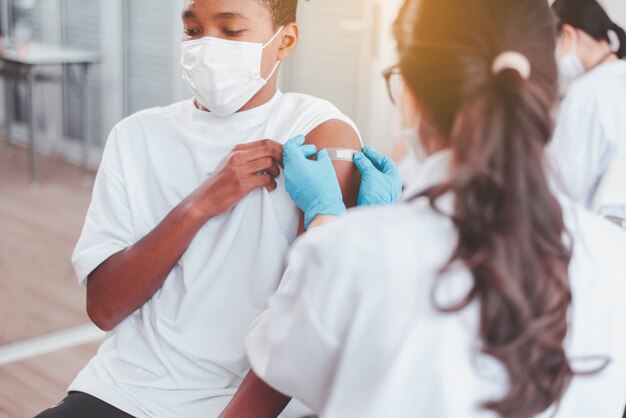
[549,0,626,218]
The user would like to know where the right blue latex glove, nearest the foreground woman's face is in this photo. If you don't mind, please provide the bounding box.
[354,147,402,206]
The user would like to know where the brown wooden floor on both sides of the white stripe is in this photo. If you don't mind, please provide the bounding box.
[0,145,97,418]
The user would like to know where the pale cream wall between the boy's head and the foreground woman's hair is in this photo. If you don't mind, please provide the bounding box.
[281,0,401,151]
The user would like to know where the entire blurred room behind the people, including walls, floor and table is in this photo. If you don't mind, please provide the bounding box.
[0,0,626,418]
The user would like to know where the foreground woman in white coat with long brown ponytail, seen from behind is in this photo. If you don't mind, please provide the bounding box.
[223,0,626,418]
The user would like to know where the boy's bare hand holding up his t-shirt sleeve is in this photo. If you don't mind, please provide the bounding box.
[190,139,283,220]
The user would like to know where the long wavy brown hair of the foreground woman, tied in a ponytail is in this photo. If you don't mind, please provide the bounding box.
[395,0,574,418]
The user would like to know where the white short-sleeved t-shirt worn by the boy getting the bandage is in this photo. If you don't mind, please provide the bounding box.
[68,92,356,418]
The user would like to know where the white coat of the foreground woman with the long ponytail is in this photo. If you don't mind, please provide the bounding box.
[246,152,626,418]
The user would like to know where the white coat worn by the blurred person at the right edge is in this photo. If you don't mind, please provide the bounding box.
[548,60,626,218]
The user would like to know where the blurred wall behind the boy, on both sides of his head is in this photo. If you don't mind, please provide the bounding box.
[0,0,400,168]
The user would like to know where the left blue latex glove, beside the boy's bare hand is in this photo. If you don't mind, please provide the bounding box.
[283,136,346,229]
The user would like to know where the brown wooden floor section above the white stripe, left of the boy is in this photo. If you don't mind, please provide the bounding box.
[0,146,91,345]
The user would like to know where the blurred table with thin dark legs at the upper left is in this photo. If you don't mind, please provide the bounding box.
[0,43,99,184]
